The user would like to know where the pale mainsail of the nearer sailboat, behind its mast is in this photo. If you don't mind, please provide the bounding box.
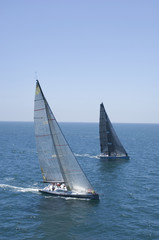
[34,82,64,182]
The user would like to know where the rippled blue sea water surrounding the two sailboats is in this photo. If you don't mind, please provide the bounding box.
[0,122,159,240]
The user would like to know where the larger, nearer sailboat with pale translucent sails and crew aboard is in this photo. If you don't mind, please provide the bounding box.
[34,80,99,200]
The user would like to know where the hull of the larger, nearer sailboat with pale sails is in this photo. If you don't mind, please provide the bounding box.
[39,189,99,200]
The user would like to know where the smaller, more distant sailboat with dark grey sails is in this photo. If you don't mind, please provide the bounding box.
[99,103,129,159]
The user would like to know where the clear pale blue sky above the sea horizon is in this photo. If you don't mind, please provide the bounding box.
[0,0,159,123]
